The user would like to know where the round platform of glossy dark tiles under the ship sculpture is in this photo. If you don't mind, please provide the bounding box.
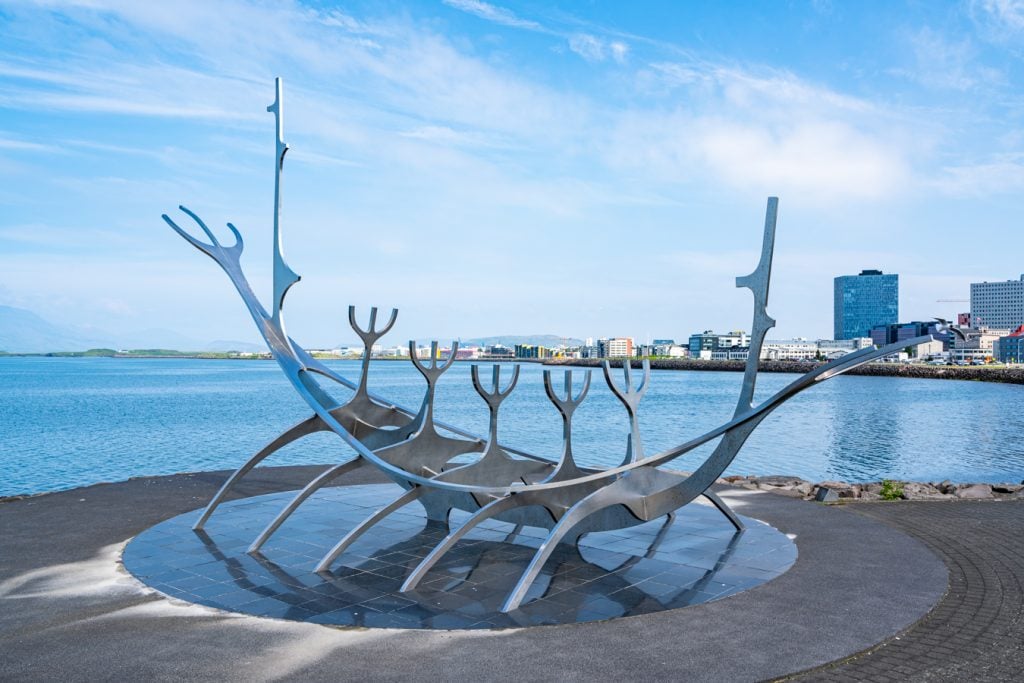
[123,484,797,629]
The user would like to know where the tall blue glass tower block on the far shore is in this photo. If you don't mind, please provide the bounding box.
[833,270,899,339]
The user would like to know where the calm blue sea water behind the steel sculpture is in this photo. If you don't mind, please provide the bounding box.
[0,358,1024,496]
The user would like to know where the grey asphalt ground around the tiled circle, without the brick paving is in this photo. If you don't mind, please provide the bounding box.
[0,466,946,681]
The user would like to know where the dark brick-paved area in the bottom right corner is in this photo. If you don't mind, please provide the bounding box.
[798,500,1024,681]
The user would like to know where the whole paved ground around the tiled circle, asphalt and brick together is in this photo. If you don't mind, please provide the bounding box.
[0,467,1024,681]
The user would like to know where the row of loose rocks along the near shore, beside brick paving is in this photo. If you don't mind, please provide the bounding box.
[720,475,1024,503]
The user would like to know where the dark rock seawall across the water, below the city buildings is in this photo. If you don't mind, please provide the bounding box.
[544,358,1024,384]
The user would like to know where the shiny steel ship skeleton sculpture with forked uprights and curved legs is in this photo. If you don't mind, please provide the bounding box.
[163,79,931,612]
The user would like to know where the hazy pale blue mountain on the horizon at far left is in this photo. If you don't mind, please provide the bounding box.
[0,306,266,353]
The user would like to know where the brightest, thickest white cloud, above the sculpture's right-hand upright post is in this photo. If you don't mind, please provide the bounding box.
[607,61,915,203]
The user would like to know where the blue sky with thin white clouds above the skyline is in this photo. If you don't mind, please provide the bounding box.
[0,0,1024,346]
